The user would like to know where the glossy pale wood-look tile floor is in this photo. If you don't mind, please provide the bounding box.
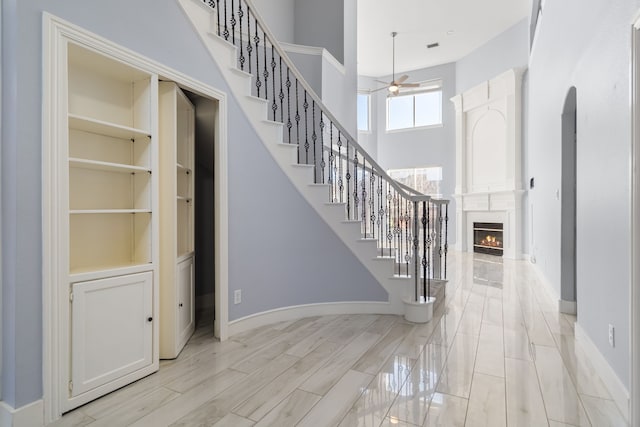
[54,254,626,427]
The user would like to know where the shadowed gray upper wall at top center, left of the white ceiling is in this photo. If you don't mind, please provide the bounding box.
[293,0,344,64]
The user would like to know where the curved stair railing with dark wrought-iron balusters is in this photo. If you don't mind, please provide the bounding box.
[202,0,449,301]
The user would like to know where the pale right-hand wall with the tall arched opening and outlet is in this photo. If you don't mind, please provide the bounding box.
[526,0,640,388]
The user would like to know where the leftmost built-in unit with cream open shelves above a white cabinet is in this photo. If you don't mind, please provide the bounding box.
[60,42,158,410]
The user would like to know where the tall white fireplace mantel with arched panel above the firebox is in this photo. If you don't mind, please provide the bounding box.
[451,69,524,258]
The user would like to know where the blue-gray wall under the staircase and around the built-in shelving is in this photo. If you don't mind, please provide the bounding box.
[1,0,386,407]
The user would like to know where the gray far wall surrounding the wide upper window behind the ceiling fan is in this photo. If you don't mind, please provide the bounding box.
[360,63,456,242]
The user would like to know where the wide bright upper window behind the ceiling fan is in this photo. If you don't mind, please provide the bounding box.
[387,82,442,130]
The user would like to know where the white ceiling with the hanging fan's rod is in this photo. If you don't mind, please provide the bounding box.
[358,0,531,77]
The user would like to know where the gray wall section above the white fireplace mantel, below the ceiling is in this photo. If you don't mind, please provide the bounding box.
[456,18,529,93]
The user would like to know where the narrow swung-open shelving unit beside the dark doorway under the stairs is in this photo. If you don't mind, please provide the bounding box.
[159,82,195,359]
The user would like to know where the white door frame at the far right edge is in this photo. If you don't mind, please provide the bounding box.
[629,12,640,426]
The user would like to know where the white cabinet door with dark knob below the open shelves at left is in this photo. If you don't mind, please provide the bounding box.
[71,272,153,397]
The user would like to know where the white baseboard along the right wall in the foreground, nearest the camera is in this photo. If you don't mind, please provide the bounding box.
[575,323,629,421]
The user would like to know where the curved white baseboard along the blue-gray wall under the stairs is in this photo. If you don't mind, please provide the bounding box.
[229,302,392,337]
